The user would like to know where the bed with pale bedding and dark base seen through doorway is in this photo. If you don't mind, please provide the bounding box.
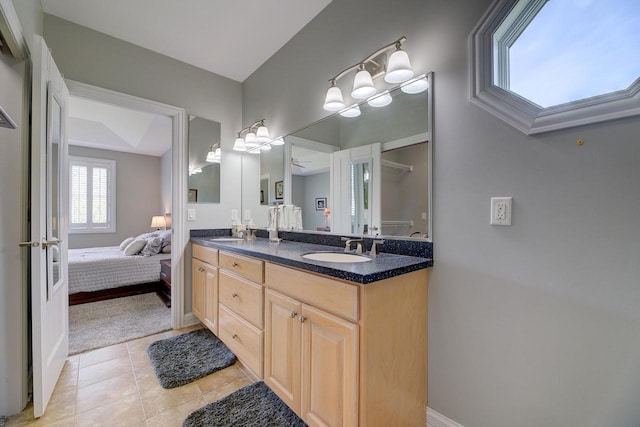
[68,233,171,305]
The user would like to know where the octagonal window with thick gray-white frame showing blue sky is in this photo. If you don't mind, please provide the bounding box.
[472,0,640,134]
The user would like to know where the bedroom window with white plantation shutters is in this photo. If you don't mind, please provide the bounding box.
[69,156,116,233]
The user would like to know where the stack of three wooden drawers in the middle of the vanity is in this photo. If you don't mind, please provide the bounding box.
[218,251,264,378]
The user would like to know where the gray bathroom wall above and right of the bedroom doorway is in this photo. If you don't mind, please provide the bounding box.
[44,14,242,313]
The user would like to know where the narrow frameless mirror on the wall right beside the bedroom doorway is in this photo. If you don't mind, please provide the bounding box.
[187,115,220,203]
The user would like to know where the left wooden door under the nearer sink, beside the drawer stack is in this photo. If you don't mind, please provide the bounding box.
[264,289,301,415]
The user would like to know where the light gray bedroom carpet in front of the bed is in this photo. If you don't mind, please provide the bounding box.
[69,293,171,355]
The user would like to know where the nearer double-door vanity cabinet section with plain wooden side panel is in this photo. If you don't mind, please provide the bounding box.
[264,263,427,427]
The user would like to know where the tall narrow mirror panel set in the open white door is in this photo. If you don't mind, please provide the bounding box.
[46,88,62,297]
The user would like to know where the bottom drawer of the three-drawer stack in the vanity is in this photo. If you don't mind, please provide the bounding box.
[218,304,263,378]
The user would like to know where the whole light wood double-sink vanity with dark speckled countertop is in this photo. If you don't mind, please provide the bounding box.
[191,237,430,427]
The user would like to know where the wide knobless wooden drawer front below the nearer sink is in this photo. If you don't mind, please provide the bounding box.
[265,262,359,321]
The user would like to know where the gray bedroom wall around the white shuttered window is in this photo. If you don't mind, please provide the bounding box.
[69,145,164,249]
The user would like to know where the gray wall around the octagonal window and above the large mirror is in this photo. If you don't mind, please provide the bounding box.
[243,0,640,427]
